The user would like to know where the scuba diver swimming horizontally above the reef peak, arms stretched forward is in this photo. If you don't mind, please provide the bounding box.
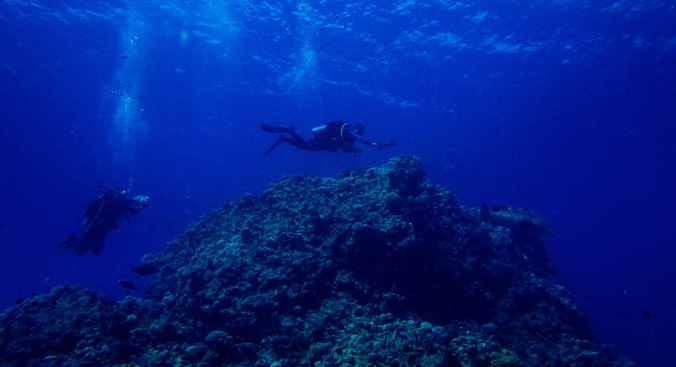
[261,120,395,156]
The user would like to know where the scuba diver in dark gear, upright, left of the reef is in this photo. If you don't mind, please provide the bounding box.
[59,186,150,255]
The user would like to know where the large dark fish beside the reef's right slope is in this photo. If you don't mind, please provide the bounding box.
[481,204,554,237]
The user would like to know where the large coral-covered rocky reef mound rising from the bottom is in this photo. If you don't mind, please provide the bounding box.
[0,157,630,367]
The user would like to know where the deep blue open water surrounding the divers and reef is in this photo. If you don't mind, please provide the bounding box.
[0,0,676,367]
